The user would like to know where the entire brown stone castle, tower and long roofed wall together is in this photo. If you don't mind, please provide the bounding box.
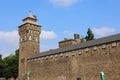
[19,15,120,80]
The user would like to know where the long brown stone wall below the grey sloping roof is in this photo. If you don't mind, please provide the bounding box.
[28,42,120,80]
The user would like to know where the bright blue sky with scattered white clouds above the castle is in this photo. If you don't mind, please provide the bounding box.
[0,0,120,57]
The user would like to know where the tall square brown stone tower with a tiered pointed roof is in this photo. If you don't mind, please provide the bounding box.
[18,13,41,80]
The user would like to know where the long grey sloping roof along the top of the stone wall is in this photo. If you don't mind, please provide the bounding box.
[28,33,120,60]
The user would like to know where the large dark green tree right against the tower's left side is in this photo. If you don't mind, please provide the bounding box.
[3,50,19,79]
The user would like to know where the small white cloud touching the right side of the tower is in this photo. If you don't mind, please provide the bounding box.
[40,30,57,39]
